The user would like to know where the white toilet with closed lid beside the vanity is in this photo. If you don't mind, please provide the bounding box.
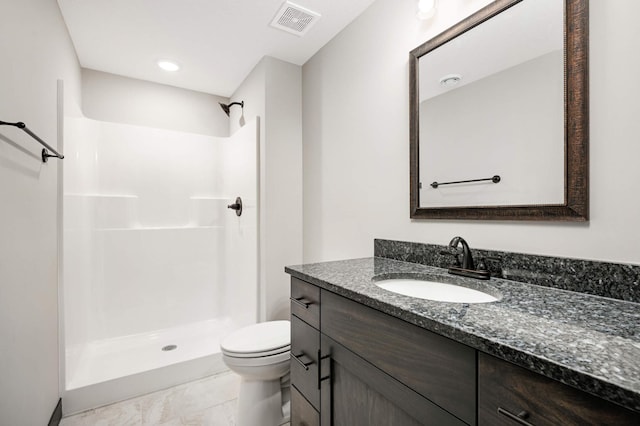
[220,321,291,426]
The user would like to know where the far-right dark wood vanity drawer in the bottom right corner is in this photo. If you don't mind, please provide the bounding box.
[478,352,640,426]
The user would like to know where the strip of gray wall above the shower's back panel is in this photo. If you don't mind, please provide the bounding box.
[82,69,229,136]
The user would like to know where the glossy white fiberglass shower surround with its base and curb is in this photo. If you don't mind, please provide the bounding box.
[62,118,259,414]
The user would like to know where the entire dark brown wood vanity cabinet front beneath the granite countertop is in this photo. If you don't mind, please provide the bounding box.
[291,278,640,426]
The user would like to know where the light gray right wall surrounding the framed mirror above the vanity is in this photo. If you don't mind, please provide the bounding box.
[303,0,640,264]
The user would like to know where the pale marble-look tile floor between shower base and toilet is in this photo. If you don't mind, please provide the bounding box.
[60,372,240,426]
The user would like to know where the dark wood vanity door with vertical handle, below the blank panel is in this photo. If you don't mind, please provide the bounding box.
[320,334,466,426]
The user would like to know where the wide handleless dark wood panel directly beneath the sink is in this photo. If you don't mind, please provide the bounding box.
[320,290,476,425]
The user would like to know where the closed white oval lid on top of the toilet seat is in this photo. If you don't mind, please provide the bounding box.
[220,321,291,353]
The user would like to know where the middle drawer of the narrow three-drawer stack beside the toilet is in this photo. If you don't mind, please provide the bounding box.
[291,315,320,409]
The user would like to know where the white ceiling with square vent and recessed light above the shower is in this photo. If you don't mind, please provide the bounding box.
[58,0,374,97]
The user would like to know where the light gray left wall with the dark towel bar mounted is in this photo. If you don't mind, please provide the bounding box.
[0,0,80,426]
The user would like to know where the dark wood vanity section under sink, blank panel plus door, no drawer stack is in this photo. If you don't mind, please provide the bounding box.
[320,290,476,426]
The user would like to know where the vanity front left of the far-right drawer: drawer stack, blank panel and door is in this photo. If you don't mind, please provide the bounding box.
[291,278,476,426]
